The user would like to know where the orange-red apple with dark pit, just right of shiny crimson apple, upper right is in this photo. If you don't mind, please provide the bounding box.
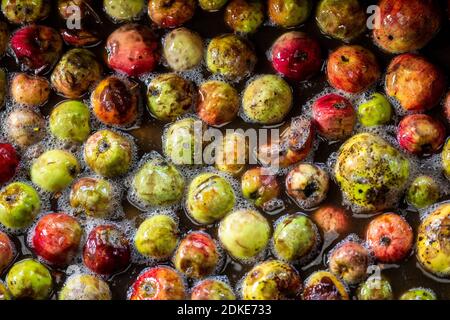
[327,45,381,93]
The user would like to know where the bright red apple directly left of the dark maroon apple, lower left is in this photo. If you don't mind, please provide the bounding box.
[32,213,83,266]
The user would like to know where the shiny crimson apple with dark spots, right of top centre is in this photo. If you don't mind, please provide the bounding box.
[272,31,322,81]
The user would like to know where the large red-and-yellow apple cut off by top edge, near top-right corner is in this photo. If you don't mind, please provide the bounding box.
[373,0,442,53]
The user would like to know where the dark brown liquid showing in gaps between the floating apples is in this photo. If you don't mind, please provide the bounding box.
[2,1,450,299]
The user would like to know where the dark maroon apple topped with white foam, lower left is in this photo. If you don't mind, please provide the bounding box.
[83,225,131,275]
